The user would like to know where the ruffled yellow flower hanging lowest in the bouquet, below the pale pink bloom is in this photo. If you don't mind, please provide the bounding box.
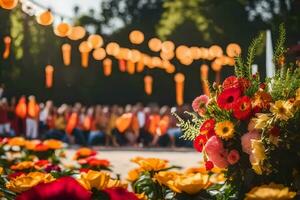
[250,140,266,174]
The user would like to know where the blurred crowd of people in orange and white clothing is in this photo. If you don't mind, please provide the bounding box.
[0,93,191,147]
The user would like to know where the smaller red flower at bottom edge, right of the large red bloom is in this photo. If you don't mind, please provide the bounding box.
[104,188,138,200]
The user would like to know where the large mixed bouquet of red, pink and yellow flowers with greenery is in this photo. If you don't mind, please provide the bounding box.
[175,25,300,199]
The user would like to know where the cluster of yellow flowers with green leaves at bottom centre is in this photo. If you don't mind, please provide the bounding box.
[127,157,225,200]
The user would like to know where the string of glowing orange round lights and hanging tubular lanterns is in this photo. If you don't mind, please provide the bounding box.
[0,0,241,105]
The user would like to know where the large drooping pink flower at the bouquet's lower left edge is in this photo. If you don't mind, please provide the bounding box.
[205,136,228,168]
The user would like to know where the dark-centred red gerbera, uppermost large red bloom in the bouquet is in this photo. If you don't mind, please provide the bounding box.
[217,88,241,110]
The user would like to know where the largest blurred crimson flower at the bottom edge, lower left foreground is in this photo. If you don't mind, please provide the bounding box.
[16,177,92,200]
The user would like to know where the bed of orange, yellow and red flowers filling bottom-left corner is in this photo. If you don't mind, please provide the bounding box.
[0,137,138,200]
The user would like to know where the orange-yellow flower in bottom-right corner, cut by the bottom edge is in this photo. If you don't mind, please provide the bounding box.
[245,183,296,200]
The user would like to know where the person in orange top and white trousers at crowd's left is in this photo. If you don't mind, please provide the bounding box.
[26,96,40,139]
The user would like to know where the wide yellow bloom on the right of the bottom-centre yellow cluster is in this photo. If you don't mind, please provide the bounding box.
[171,173,211,194]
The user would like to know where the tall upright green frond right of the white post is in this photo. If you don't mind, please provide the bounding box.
[273,23,286,65]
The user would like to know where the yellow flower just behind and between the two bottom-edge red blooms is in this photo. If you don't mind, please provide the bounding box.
[77,170,110,190]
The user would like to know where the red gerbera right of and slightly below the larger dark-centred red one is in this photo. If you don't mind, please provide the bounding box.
[233,96,251,120]
